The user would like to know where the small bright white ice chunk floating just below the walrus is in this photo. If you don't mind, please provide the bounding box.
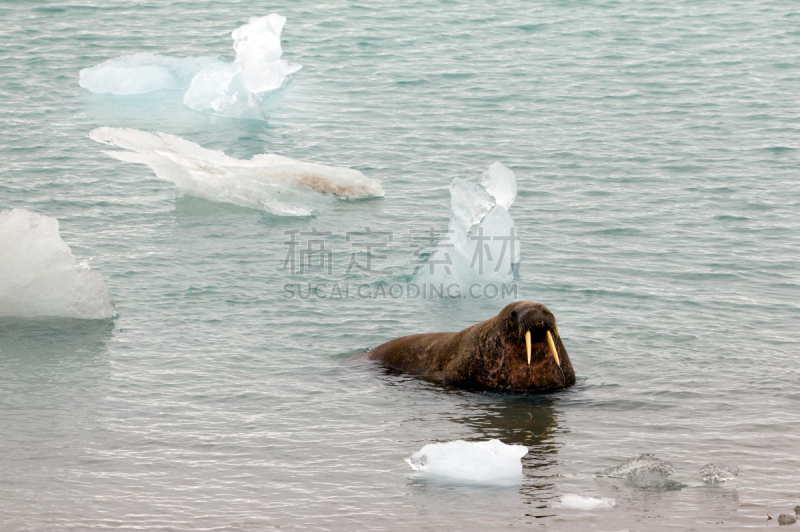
[406,440,528,484]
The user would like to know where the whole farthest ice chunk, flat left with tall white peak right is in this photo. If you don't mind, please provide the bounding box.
[80,13,302,117]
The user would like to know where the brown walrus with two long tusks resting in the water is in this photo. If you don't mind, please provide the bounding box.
[367,301,575,393]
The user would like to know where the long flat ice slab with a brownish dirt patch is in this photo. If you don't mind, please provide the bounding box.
[89,127,383,216]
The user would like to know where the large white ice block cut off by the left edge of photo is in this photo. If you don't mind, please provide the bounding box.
[0,209,114,319]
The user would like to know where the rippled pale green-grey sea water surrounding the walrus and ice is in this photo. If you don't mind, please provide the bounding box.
[0,0,800,531]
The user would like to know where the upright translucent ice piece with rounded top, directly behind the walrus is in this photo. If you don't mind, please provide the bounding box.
[417,162,520,286]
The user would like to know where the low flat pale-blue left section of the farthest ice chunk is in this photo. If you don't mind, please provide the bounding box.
[80,53,222,95]
